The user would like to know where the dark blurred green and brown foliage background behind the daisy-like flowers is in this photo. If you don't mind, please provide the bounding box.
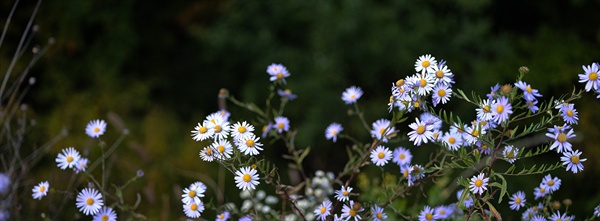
[0,0,600,220]
